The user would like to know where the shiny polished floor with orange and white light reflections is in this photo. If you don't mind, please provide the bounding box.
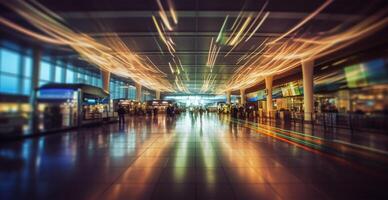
[0,114,388,200]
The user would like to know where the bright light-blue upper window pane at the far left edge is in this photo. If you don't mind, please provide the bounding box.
[0,49,20,74]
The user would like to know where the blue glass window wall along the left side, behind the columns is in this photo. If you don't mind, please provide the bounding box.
[0,40,136,99]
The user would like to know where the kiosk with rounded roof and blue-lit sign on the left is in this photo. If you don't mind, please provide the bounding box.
[38,84,117,132]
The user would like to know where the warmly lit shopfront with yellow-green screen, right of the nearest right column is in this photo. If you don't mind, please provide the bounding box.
[314,58,388,114]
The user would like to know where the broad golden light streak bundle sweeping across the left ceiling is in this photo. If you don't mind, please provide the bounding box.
[1,0,175,92]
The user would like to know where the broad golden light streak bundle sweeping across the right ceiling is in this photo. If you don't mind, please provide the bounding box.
[217,9,388,92]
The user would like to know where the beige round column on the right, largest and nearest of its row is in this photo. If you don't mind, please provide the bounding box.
[302,60,314,121]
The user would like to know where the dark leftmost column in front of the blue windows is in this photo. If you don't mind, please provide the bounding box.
[29,49,42,134]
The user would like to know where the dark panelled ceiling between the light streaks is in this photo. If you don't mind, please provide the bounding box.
[1,0,385,93]
